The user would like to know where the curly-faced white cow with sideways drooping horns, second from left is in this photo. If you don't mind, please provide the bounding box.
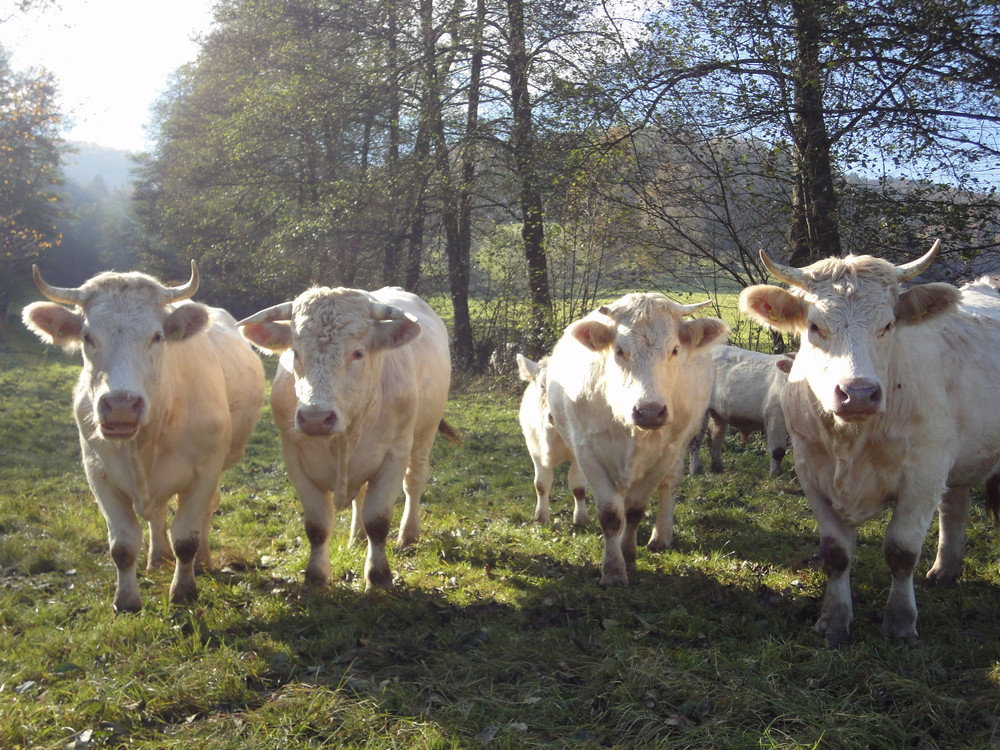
[238,287,452,589]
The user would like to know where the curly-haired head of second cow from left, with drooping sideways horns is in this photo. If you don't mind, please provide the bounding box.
[237,287,420,437]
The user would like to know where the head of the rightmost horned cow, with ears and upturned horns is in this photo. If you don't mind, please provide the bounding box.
[740,242,959,423]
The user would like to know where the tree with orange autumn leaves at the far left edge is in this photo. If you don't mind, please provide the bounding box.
[0,48,63,311]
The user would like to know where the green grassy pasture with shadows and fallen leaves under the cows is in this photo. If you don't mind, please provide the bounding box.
[0,326,1000,750]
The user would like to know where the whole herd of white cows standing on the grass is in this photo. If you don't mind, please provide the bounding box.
[23,243,1000,645]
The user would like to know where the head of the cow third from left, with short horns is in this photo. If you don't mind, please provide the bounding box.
[567,293,729,430]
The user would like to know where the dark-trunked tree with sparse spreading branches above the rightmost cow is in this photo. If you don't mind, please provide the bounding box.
[623,0,1000,272]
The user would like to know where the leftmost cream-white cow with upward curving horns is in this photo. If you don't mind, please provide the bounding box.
[23,261,264,611]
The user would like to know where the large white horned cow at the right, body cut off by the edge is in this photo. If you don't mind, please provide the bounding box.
[740,242,1000,645]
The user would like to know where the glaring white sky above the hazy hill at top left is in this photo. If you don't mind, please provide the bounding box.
[0,0,214,152]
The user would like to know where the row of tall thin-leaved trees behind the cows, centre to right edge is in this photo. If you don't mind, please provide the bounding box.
[3,0,1000,368]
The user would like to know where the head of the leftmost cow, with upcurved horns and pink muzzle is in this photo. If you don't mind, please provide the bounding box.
[22,261,208,440]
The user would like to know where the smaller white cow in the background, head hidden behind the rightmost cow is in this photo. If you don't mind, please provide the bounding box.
[691,346,792,477]
